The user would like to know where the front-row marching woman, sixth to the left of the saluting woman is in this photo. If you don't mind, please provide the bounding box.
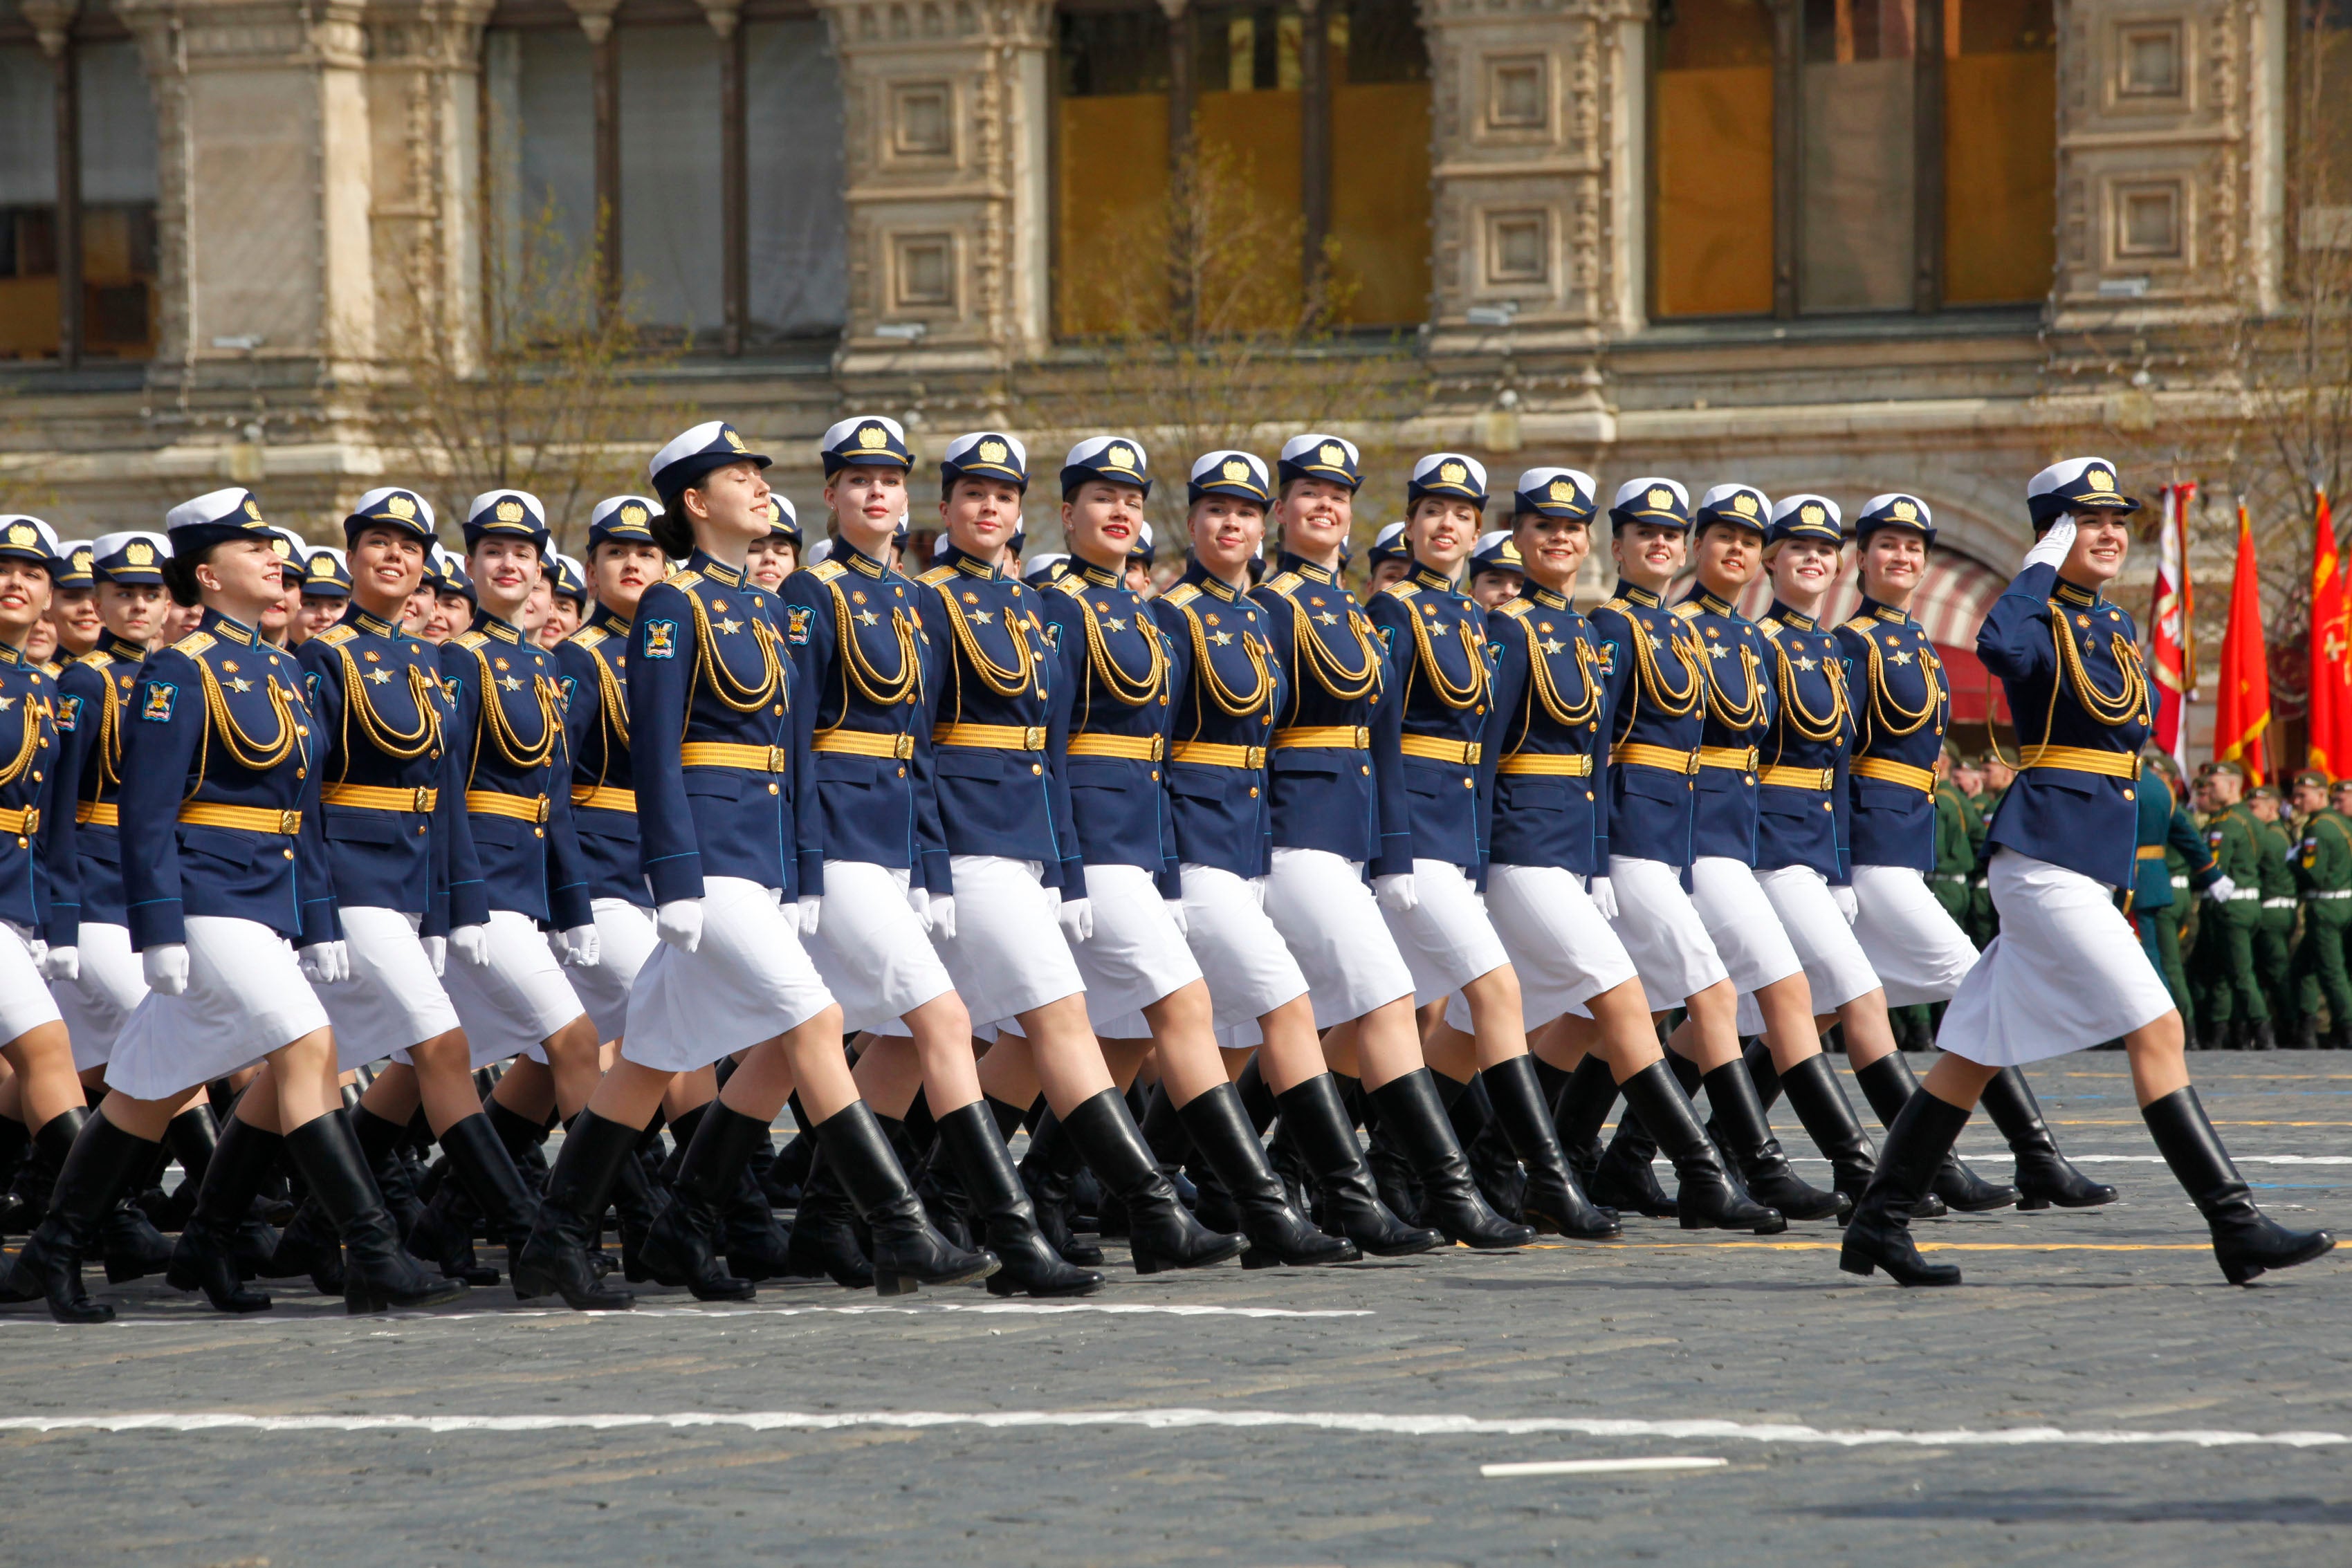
[1366,452,1621,1242]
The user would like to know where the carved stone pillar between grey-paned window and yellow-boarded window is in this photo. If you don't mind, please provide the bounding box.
[825,0,1054,395]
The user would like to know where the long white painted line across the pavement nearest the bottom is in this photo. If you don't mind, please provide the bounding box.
[0,1408,2352,1448]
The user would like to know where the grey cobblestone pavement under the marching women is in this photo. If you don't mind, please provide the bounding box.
[0,1053,2352,1568]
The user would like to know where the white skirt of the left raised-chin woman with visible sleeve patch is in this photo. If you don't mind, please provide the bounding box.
[106,914,327,1100]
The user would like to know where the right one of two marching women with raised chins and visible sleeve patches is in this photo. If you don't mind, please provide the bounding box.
[515,421,998,1309]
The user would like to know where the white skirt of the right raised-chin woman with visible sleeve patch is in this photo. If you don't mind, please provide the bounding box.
[621,877,833,1072]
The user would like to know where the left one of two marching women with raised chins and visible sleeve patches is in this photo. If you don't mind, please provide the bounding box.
[12,489,466,1321]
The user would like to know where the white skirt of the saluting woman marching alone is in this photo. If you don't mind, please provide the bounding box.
[1936,849,2174,1067]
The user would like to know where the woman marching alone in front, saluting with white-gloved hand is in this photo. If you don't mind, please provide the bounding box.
[1839,459,2335,1286]
